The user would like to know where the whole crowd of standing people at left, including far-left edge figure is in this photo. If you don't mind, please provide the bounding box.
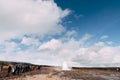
[0,64,41,77]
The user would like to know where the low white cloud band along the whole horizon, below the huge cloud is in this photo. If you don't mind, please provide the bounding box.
[0,34,120,67]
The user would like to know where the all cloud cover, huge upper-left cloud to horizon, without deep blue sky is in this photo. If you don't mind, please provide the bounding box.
[0,0,120,67]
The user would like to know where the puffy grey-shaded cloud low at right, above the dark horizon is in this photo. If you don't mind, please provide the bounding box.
[72,42,120,67]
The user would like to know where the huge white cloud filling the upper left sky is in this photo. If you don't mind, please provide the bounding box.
[0,0,70,40]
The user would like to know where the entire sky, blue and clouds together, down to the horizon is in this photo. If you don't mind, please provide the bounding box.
[0,0,120,67]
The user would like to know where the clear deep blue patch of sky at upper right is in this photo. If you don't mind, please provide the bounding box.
[55,0,120,41]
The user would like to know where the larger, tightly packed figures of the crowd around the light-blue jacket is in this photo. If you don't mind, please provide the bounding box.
[6,64,31,76]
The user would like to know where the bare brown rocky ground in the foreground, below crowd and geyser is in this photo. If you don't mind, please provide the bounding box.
[0,67,120,80]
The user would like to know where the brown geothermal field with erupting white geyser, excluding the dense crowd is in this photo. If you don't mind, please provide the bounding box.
[0,62,120,80]
